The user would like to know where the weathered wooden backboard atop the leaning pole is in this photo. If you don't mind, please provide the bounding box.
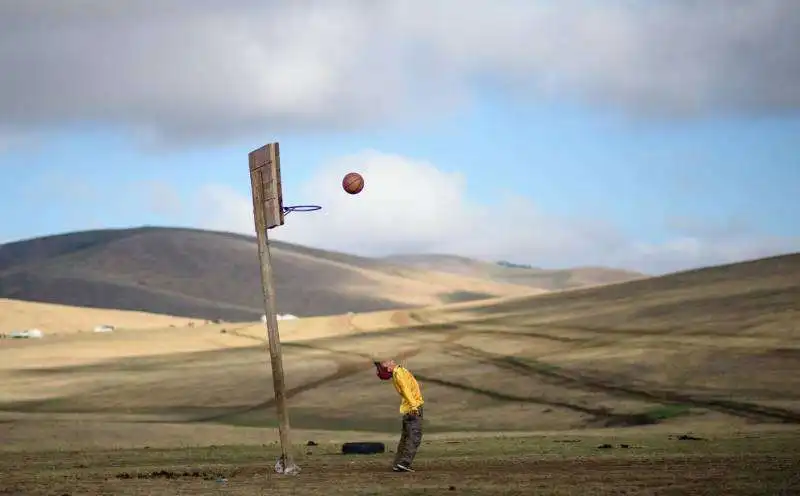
[249,143,290,229]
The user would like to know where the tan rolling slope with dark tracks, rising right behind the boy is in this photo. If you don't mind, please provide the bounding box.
[0,255,800,449]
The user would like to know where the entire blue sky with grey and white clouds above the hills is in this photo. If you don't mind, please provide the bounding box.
[0,0,800,274]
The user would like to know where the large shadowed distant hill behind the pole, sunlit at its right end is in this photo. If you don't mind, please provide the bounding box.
[0,227,529,320]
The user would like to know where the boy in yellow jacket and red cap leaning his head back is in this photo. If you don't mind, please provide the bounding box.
[375,360,425,472]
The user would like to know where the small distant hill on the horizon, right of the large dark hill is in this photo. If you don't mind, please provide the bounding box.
[383,254,646,291]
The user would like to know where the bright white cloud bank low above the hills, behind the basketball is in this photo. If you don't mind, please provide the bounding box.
[189,151,800,274]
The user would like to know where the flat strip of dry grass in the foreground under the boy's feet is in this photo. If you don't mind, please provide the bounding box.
[0,432,800,496]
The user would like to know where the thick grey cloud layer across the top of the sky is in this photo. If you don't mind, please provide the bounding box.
[0,0,800,142]
